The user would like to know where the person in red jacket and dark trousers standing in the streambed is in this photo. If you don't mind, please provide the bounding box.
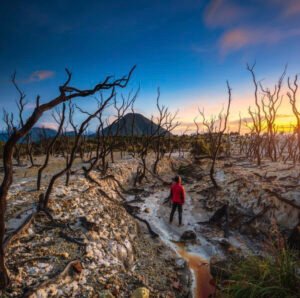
[170,176,185,226]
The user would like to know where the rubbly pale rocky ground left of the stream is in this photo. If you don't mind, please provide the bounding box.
[3,160,190,297]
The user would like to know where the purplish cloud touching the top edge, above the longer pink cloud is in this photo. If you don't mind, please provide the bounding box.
[204,0,246,27]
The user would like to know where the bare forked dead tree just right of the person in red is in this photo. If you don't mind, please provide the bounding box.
[199,82,231,189]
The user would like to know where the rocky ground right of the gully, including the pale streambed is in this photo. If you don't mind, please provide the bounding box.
[129,158,300,297]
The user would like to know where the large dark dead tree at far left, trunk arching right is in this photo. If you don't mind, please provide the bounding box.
[0,68,134,289]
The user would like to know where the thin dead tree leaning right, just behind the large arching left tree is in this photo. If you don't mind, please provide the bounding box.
[37,103,66,190]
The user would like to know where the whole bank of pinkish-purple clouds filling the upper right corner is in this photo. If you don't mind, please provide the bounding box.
[203,0,300,55]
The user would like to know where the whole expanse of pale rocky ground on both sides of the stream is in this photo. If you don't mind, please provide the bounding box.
[4,155,300,297]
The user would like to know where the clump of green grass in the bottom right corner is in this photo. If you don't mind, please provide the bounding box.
[219,249,300,298]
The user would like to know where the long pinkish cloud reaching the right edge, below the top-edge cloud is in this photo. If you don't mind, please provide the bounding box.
[220,27,300,54]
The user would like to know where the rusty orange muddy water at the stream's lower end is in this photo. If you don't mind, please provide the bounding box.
[177,243,215,298]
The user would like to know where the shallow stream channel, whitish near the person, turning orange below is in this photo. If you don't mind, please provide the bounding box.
[128,192,215,298]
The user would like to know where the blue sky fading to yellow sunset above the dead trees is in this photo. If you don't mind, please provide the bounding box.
[0,0,300,133]
